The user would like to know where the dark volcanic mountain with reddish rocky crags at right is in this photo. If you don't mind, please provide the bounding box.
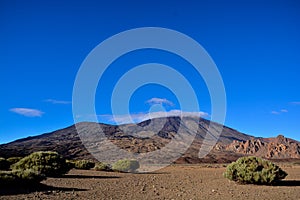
[0,117,300,163]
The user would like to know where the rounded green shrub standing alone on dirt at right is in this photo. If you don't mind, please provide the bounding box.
[224,156,287,184]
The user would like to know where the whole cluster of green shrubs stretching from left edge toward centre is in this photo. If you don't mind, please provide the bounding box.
[0,151,139,186]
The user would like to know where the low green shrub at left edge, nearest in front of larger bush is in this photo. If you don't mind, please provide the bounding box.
[0,169,46,186]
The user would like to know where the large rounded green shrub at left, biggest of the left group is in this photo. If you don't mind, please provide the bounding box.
[11,151,69,177]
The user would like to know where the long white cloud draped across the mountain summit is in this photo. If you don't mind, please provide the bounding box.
[97,110,209,124]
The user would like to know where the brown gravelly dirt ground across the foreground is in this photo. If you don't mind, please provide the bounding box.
[0,165,300,200]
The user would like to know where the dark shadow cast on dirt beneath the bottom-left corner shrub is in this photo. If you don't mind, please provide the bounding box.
[0,183,86,196]
